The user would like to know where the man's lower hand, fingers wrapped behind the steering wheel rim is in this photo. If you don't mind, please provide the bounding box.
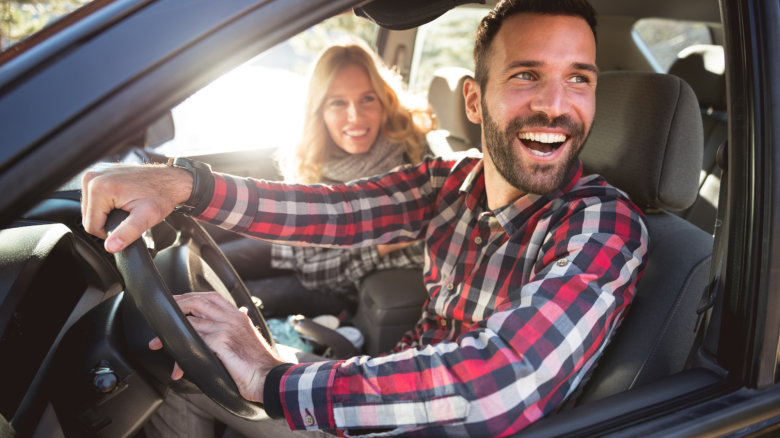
[149,292,285,403]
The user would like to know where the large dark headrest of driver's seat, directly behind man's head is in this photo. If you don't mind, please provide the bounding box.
[580,72,704,210]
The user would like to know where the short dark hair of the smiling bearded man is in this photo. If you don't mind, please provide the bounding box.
[474,0,596,92]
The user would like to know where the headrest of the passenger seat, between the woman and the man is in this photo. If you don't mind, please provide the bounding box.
[428,67,482,147]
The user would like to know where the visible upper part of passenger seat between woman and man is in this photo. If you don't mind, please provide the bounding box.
[427,67,482,155]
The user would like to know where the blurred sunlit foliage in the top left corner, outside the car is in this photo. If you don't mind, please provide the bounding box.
[0,0,92,51]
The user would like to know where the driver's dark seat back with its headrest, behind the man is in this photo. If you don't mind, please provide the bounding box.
[574,72,712,405]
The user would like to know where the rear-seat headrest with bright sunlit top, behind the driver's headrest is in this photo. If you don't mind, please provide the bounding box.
[669,44,726,111]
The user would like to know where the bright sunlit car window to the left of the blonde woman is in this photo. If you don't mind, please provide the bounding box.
[155,14,376,156]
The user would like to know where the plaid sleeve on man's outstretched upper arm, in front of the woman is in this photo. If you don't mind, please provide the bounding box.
[196,158,456,248]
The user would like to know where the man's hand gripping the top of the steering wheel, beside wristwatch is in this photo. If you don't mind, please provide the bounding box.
[81,164,192,253]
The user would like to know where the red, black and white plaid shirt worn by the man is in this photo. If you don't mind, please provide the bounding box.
[198,153,648,436]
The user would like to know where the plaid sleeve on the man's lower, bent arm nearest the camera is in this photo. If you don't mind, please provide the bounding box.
[272,200,648,436]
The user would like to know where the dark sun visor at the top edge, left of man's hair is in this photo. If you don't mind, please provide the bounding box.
[355,0,485,30]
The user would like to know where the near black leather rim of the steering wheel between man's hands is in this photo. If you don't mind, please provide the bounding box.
[106,210,267,421]
